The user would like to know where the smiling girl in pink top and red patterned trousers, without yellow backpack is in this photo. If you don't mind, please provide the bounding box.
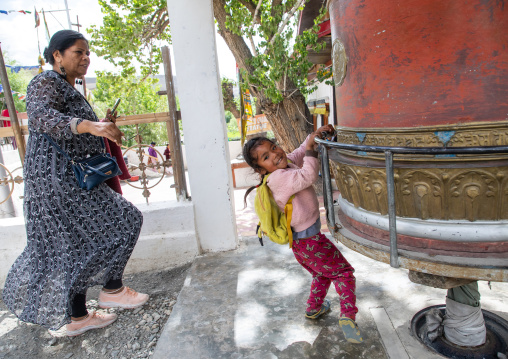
[243,125,363,343]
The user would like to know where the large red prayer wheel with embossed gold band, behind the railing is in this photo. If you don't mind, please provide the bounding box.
[329,0,508,281]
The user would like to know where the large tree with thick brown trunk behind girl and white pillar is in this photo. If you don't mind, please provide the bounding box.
[91,0,329,151]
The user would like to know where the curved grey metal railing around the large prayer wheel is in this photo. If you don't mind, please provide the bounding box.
[315,138,508,268]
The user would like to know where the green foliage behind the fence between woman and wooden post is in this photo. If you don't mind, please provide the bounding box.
[92,71,168,146]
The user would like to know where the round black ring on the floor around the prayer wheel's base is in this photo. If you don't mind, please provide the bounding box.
[411,304,508,359]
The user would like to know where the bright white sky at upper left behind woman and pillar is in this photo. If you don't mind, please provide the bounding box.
[0,0,236,79]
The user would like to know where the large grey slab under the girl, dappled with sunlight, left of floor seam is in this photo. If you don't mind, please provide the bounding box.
[154,237,386,359]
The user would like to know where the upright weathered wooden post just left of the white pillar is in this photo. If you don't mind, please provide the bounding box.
[161,46,188,201]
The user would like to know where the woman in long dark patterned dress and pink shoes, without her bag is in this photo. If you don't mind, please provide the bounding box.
[3,30,148,336]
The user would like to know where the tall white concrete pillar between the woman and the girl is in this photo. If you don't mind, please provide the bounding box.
[168,0,238,252]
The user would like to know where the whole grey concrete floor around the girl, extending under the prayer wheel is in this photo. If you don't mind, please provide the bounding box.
[153,237,508,359]
